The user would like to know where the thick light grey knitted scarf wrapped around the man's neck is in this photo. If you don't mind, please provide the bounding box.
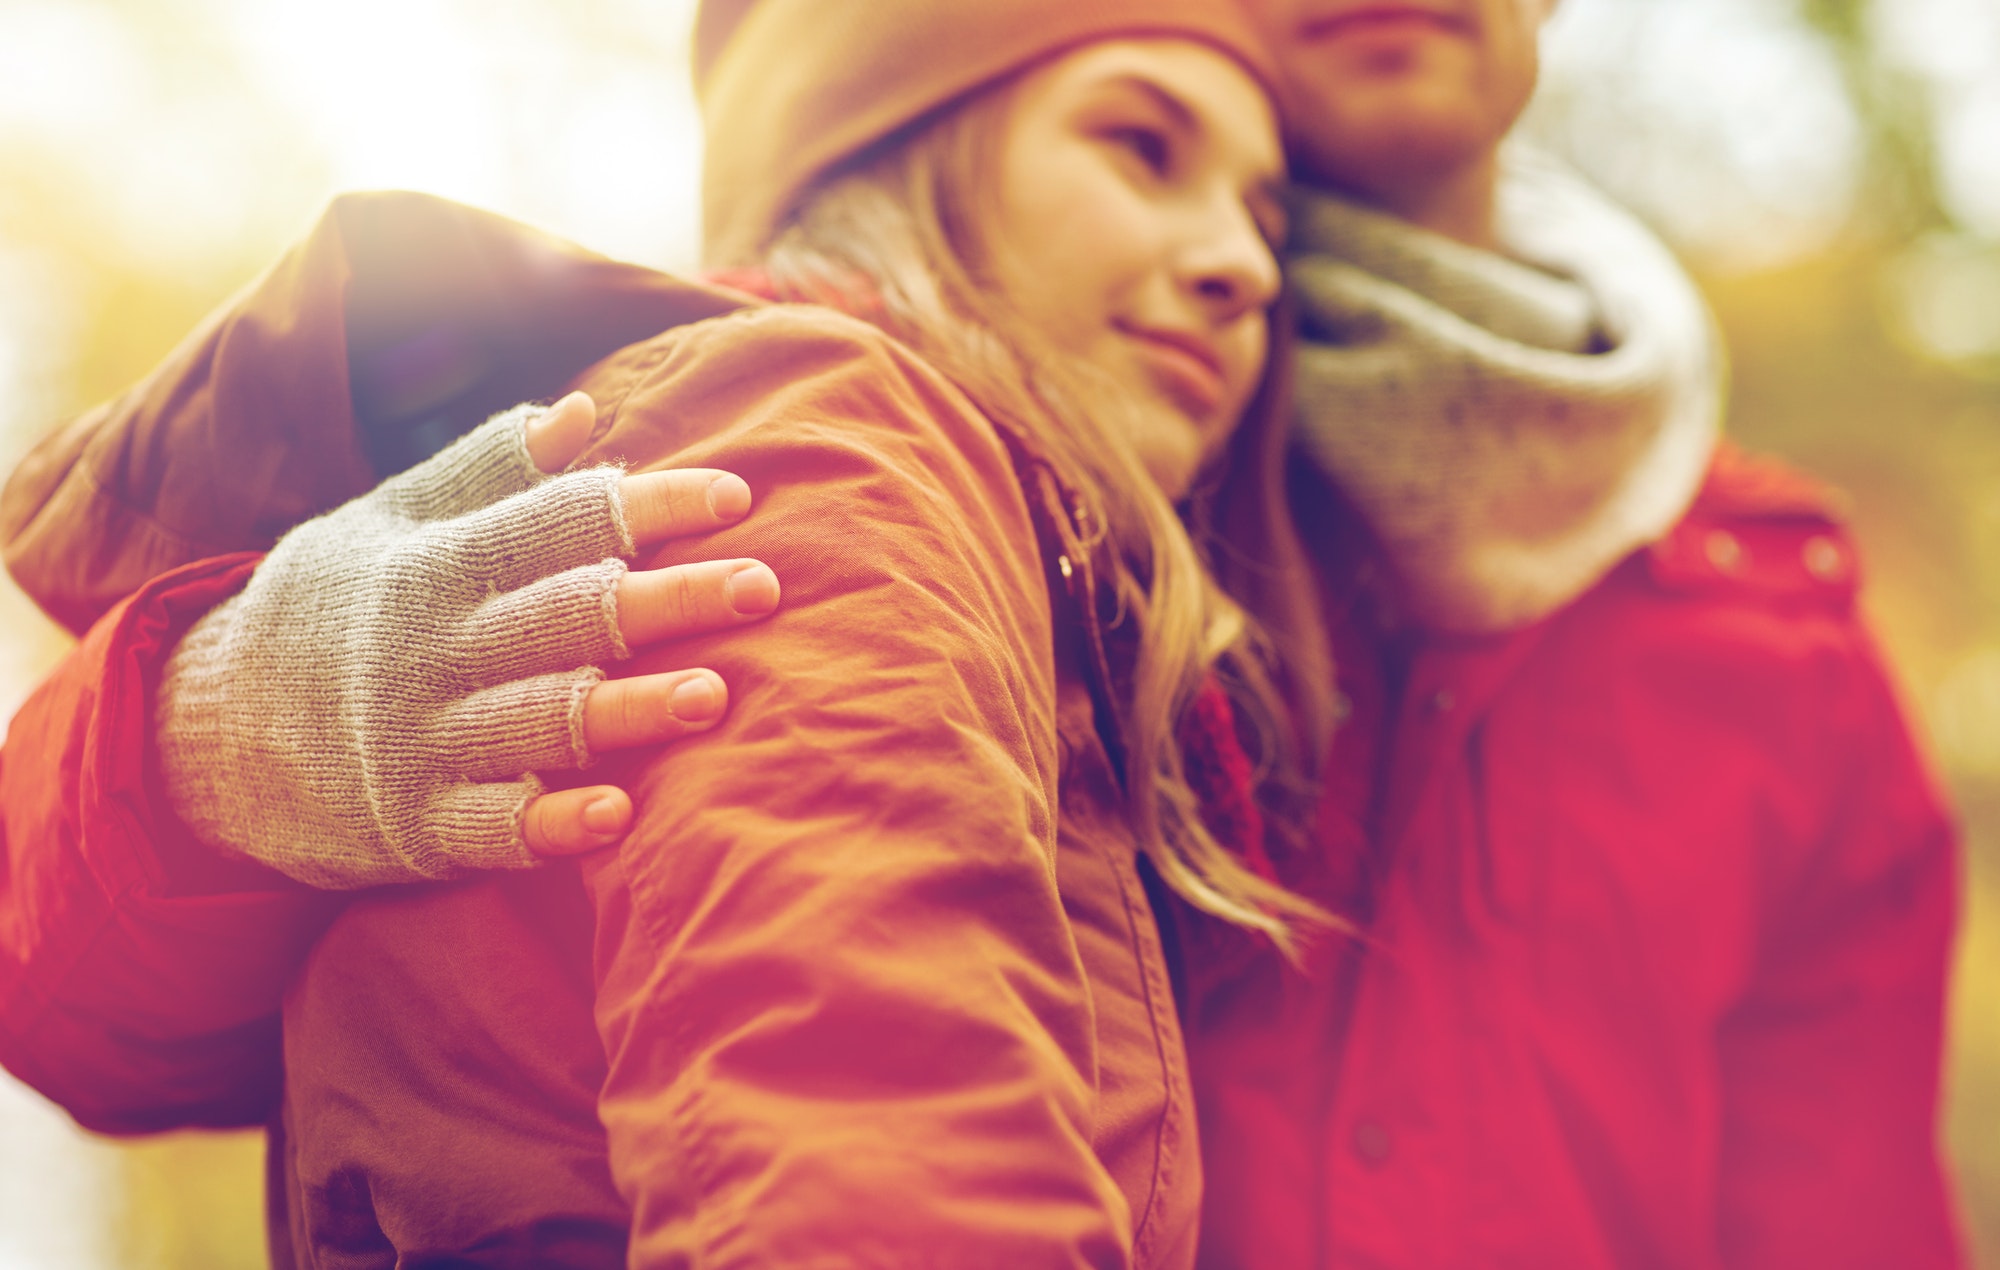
[1290,150,1724,632]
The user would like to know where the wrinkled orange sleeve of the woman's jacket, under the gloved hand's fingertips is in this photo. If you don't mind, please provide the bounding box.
[576,308,1132,1268]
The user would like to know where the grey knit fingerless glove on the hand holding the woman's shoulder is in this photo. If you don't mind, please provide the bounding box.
[154,406,632,890]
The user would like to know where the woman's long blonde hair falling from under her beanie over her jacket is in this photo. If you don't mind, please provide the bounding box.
[762,74,1332,954]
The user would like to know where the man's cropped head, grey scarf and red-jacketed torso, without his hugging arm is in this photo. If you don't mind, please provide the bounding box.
[1182,0,1960,1268]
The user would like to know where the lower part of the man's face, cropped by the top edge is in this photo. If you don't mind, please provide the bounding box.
[1248,0,1554,206]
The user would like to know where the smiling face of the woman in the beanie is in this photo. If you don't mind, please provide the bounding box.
[988,40,1284,496]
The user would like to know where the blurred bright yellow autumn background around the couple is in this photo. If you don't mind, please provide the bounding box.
[0,0,2000,1270]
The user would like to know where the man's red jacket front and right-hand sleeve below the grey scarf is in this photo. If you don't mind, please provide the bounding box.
[1186,452,1960,1270]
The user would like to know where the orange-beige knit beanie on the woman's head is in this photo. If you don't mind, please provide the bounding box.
[694,0,1278,266]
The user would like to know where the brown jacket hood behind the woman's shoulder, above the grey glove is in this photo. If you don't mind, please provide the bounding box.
[0,192,744,634]
